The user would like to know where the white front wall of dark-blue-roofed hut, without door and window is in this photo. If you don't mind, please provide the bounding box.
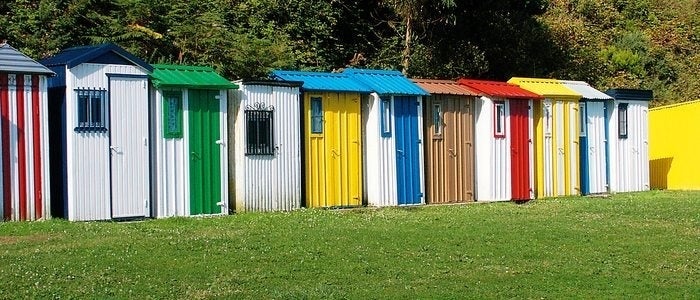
[66,63,147,221]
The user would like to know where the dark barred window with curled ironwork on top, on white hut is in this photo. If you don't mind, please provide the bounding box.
[245,104,274,155]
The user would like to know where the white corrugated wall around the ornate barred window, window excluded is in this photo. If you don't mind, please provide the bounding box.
[229,84,302,212]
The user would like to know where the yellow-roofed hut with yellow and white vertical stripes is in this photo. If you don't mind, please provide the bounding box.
[508,77,581,198]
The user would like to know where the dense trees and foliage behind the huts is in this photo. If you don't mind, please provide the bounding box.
[0,0,700,103]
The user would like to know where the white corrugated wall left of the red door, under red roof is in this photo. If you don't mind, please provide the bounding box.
[475,97,511,201]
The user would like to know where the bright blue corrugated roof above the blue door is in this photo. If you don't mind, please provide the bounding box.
[343,68,430,96]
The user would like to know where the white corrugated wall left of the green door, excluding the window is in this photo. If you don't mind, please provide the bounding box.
[151,90,189,218]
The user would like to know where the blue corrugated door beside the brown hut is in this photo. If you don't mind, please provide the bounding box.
[394,96,423,205]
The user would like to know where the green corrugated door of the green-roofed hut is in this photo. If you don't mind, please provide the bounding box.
[188,90,222,215]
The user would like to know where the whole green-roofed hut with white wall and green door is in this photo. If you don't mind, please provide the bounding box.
[150,64,237,218]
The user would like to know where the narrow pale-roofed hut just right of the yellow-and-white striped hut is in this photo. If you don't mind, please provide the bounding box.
[562,80,612,195]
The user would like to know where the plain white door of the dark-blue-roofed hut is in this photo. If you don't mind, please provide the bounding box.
[109,77,150,218]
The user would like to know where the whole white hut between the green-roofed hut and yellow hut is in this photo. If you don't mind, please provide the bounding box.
[229,80,302,212]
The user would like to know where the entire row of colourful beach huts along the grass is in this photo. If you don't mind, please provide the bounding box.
[0,44,672,220]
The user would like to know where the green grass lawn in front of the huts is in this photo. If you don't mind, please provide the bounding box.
[0,191,700,299]
